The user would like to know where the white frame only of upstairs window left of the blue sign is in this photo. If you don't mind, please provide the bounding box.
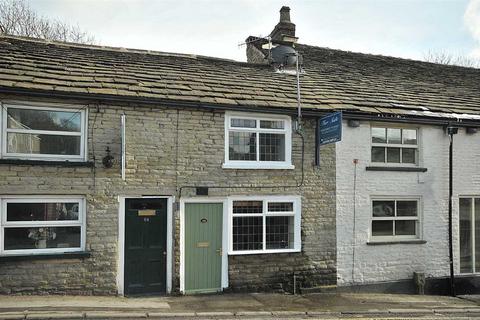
[222,112,295,169]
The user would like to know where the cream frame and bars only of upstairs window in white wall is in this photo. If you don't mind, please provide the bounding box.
[370,123,420,167]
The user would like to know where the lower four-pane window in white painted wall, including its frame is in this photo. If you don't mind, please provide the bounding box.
[371,198,420,240]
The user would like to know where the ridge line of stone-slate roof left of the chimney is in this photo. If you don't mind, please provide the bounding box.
[0,34,249,64]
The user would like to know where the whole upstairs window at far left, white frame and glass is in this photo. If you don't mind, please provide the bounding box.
[1,104,86,161]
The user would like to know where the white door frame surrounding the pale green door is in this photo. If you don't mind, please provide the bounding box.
[180,197,228,294]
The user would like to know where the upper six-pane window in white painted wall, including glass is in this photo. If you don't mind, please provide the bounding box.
[372,127,418,165]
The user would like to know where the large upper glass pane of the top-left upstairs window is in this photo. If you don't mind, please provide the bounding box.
[7,108,81,132]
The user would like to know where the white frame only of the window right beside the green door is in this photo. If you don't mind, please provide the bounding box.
[227,196,302,255]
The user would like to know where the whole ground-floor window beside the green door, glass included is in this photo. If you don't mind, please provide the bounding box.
[229,196,301,254]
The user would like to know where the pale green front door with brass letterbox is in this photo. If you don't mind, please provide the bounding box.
[185,203,224,293]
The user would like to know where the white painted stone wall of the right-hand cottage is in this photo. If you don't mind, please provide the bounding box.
[336,121,480,286]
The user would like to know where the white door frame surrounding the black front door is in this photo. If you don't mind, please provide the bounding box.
[117,195,175,296]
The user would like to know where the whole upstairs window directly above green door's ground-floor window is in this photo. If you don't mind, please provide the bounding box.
[223,113,294,169]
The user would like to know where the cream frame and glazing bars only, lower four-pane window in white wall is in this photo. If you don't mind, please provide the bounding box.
[370,196,423,242]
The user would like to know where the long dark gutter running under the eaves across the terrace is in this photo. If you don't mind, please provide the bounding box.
[0,87,480,128]
